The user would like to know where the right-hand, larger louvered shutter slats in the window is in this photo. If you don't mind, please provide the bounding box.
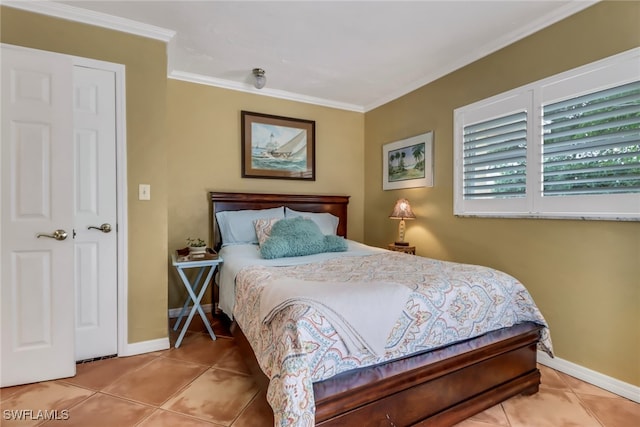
[542,81,640,196]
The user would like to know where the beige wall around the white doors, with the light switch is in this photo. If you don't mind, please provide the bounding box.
[0,7,168,343]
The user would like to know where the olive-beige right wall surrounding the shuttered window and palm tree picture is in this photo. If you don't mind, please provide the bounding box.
[364,2,640,386]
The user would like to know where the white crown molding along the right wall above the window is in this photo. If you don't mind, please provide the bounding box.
[364,0,601,112]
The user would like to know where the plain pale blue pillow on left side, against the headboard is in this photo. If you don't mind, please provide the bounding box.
[216,206,284,245]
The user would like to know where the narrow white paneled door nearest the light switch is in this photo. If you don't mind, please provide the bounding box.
[73,66,118,360]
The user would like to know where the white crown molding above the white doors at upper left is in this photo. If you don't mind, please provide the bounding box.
[2,1,176,42]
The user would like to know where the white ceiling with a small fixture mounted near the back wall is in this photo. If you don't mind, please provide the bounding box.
[12,0,596,112]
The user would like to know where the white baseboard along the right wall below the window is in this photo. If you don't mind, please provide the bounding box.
[538,351,640,403]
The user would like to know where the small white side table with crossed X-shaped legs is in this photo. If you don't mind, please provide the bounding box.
[171,253,223,348]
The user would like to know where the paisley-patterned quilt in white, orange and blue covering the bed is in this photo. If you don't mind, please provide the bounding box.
[234,252,552,427]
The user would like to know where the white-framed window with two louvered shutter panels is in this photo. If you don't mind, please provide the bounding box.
[454,48,640,220]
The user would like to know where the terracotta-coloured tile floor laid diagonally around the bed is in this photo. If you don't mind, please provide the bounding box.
[0,312,640,427]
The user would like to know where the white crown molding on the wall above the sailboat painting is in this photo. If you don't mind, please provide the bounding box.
[168,70,365,113]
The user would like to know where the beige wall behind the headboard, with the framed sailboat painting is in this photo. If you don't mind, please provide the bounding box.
[167,80,364,307]
